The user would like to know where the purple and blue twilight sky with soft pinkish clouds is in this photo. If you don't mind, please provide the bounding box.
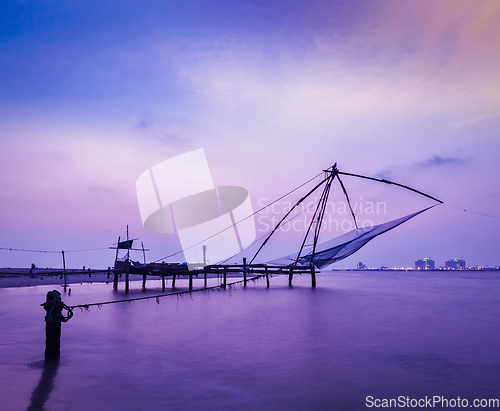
[0,0,500,268]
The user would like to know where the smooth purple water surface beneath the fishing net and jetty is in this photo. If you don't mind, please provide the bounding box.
[0,272,500,411]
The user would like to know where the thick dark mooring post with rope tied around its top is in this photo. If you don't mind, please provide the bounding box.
[40,290,73,361]
